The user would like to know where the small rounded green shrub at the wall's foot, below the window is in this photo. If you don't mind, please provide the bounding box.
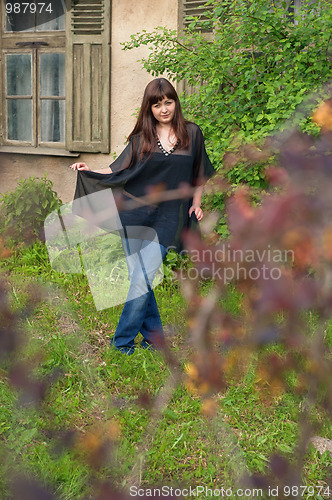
[0,174,62,241]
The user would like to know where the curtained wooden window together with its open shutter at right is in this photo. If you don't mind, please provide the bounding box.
[0,0,110,153]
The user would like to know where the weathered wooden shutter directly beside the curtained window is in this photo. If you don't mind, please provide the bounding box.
[66,0,111,153]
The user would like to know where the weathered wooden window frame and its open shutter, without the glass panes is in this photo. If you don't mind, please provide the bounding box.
[0,0,112,156]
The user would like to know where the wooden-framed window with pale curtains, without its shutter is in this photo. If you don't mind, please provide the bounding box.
[1,0,65,148]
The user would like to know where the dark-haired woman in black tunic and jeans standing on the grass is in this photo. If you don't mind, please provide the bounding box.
[71,78,214,354]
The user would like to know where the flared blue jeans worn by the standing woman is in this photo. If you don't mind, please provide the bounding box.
[111,238,167,354]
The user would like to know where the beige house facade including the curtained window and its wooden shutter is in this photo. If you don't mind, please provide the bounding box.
[0,0,187,202]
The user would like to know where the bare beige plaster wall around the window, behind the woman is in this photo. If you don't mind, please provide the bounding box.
[0,0,178,202]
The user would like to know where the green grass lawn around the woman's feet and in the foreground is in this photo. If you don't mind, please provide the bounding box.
[0,240,332,500]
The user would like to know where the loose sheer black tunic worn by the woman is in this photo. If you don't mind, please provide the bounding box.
[75,122,215,251]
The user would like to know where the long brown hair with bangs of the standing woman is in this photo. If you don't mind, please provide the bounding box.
[128,78,189,159]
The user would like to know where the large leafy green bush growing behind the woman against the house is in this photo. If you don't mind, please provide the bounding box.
[124,0,332,234]
